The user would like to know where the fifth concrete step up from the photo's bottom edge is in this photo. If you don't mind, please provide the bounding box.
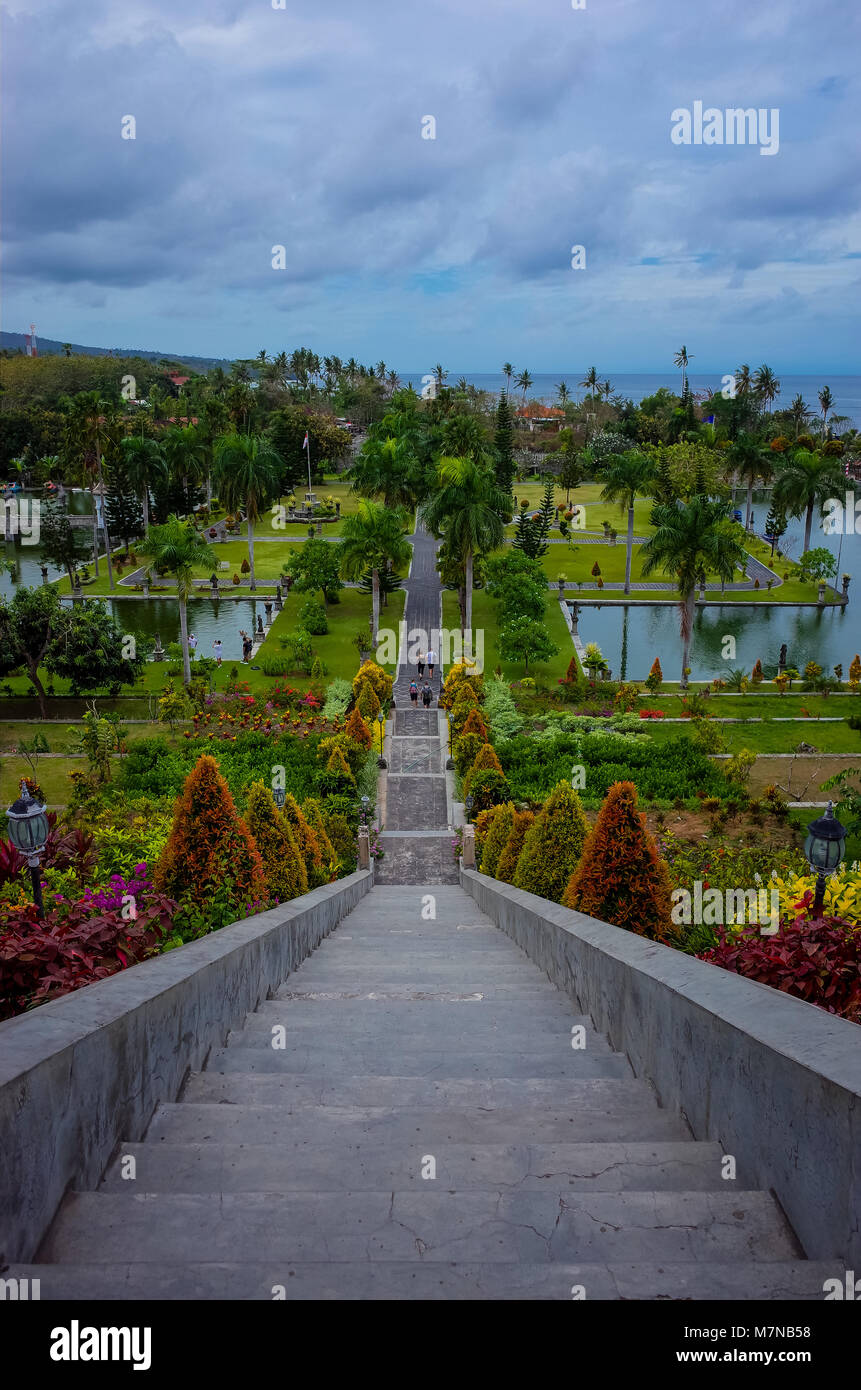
[180,1068,657,1106]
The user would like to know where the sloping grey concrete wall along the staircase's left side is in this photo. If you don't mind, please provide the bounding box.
[0,870,373,1266]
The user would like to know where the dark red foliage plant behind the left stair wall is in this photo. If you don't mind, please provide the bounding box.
[0,892,177,1019]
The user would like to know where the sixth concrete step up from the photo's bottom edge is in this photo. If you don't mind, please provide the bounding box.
[204,1038,631,1080]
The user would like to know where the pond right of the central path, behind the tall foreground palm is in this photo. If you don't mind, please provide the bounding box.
[579,602,861,681]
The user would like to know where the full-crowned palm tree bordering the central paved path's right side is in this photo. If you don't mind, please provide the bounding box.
[421,455,512,631]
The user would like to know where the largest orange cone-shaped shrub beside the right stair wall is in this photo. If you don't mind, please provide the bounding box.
[562,783,677,941]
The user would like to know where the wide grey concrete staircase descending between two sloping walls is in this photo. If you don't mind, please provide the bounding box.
[17,884,833,1300]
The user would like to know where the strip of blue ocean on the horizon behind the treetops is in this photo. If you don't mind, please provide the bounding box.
[401,363,861,430]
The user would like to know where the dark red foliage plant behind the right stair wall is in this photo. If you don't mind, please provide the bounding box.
[700,911,861,1023]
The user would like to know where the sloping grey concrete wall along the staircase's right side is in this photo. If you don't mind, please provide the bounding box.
[460,869,861,1269]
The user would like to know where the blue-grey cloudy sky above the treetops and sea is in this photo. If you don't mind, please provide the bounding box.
[3,0,861,374]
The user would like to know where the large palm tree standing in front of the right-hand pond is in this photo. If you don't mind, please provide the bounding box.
[643,495,747,689]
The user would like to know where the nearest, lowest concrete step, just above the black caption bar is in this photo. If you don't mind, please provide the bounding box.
[4,1259,842,1301]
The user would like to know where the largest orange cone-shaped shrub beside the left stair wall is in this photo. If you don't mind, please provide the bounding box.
[153,753,267,916]
